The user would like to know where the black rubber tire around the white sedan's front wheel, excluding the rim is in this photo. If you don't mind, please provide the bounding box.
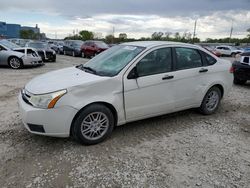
[72,104,115,145]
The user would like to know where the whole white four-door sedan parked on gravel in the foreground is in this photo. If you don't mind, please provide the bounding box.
[19,41,233,144]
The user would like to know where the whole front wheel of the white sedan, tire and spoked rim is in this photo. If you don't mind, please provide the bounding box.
[72,104,115,145]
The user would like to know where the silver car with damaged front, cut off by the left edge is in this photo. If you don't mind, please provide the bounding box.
[0,40,43,69]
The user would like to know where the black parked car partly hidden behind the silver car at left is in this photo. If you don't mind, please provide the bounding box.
[26,41,56,62]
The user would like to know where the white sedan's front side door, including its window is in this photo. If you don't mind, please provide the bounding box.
[124,47,175,121]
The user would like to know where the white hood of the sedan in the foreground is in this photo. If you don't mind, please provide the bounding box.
[25,67,109,94]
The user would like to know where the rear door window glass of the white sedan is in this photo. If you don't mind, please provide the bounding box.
[175,48,202,70]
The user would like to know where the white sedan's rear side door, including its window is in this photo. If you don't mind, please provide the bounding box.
[173,47,208,110]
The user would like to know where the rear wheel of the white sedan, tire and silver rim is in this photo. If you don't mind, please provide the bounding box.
[199,87,222,115]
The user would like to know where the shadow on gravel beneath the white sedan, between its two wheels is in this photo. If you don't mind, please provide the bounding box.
[107,109,203,146]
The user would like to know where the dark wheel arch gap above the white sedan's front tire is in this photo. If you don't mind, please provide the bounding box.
[70,101,118,136]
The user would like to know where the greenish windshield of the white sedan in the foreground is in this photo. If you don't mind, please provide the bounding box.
[83,45,145,76]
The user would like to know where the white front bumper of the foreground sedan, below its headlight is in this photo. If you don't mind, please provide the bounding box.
[18,93,78,137]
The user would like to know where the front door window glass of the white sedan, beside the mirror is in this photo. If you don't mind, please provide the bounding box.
[136,48,172,76]
